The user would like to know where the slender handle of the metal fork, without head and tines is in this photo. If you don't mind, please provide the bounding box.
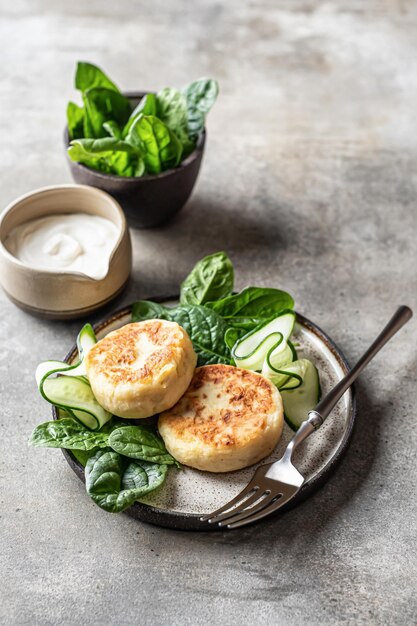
[284,305,413,460]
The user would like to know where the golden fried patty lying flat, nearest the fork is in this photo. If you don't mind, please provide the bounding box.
[158,365,283,472]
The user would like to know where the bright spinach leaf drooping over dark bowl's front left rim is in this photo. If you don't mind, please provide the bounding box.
[68,137,145,176]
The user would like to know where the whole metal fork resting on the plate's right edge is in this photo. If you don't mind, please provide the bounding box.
[200,305,413,528]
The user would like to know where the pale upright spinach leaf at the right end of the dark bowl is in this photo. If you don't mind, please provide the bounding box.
[184,78,219,141]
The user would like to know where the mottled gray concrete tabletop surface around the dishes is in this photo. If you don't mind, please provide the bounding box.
[0,0,417,626]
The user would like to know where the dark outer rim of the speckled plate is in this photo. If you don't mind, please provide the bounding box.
[52,294,356,531]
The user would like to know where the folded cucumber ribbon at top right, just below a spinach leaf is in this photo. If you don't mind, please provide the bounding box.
[232,311,295,371]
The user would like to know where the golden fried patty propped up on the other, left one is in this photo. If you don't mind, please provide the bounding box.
[85,320,197,418]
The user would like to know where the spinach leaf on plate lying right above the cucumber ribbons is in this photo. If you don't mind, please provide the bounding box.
[206,287,294,326]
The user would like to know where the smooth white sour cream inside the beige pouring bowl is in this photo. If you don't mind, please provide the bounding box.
[5,213,120,280]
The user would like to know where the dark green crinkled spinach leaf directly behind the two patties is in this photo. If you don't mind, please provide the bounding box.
[132,300,230,365]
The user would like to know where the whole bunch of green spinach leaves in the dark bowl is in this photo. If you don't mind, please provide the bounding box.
[67,62,219,177]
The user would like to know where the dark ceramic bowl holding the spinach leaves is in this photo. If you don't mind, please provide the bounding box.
[64,92,206,228]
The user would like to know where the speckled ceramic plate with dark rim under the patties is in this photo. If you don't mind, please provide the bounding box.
[55,298,355,530]
